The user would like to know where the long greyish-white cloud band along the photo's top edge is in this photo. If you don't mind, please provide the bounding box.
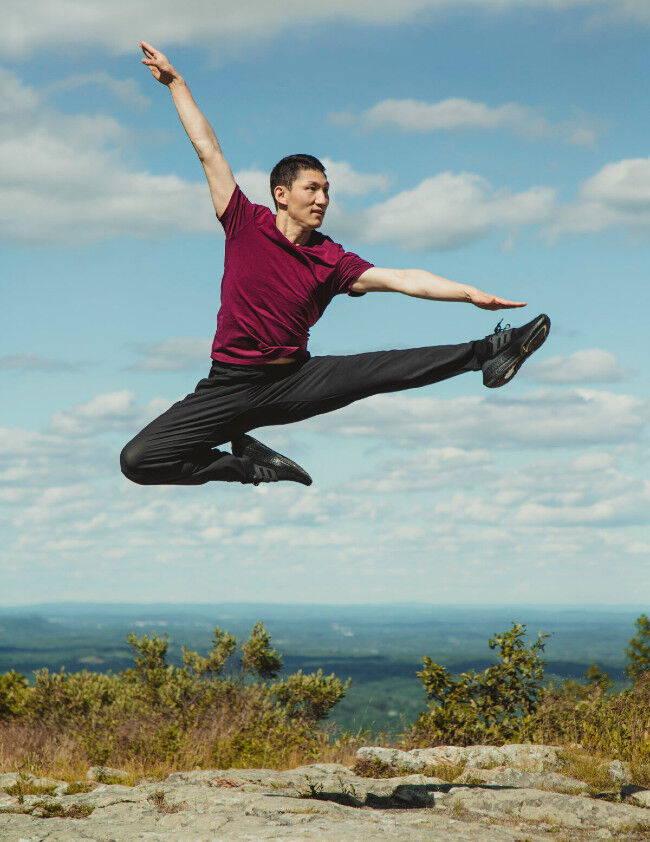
[0,0,650,59]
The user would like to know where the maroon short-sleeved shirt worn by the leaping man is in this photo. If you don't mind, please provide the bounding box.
[212,186,373,365]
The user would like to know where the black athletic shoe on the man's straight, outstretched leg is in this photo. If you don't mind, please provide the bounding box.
[481,313,551,389]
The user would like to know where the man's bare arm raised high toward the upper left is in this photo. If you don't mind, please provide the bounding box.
[140,41,235,216]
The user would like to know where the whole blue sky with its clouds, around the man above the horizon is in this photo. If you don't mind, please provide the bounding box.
[0,0,650,605]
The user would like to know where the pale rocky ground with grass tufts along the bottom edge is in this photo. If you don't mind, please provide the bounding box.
[0,746,650,842]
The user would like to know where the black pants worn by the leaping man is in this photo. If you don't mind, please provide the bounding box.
[120,342,480,485]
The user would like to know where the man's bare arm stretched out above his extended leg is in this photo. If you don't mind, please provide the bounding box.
[350,266,526,310]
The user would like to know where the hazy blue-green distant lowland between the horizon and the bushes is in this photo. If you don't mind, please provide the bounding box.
[0,603,636,733]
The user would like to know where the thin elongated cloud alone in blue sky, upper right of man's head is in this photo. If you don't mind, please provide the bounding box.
[329,97,596,145]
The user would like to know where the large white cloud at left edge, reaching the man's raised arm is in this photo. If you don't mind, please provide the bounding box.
[0,71,218,246]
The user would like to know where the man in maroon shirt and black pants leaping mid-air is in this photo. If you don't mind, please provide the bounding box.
[120,41,550,485]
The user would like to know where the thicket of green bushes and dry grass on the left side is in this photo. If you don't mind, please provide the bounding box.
[0,623,349,773]
